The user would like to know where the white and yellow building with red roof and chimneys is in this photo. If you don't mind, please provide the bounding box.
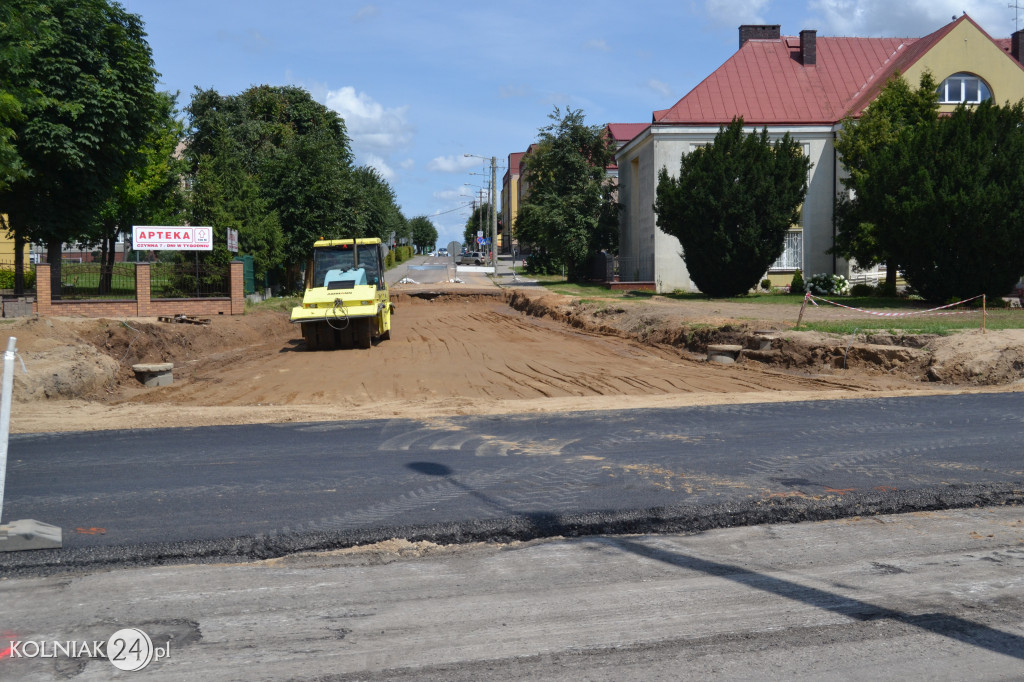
[616,14,1024,292]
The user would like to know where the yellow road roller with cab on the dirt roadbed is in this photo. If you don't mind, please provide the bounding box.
[292,239,394,350]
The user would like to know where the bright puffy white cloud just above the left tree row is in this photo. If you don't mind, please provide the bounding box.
[326,86,414,156]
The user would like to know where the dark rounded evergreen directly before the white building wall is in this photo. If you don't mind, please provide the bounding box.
[654,118,811,297]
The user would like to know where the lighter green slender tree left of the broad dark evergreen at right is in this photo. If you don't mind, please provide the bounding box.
[830,72,938,293]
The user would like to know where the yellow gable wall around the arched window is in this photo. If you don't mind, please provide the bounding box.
[903,22,1024,112]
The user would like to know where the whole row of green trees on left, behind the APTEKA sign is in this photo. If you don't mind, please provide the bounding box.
[0,0,421,291]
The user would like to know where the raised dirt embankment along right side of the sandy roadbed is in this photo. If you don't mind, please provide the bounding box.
[501,292,1024,386]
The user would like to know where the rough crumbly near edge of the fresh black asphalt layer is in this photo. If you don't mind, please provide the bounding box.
[0,481,1024,578]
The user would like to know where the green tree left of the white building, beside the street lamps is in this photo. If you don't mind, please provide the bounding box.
[515,106,618,280]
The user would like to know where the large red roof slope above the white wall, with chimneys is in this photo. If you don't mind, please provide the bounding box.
[654,14,1001,125]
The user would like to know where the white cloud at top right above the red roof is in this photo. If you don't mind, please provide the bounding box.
[808,0,1014,38]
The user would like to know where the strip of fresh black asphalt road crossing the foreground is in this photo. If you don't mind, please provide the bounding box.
[0,393,1024,572]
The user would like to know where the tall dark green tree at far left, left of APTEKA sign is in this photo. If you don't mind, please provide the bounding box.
[0,0,158,291]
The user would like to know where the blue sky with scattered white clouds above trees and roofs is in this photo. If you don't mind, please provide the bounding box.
[123,0,1011,245]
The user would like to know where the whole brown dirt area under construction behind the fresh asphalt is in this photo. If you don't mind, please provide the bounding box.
[3,291,1024,432]
